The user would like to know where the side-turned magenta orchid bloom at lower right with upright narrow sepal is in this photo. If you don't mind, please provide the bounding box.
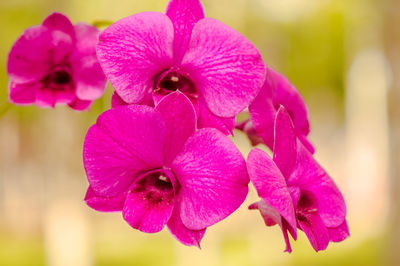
[247,107,349,252]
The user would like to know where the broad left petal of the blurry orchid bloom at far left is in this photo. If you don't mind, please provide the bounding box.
[7,26,72,83]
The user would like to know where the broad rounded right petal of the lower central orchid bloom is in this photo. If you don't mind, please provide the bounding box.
[172,128,249,230]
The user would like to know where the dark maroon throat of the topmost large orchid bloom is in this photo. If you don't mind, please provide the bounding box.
[154,69,197,98]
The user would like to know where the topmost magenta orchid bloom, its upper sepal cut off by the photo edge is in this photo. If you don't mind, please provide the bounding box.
[97,0,266,134]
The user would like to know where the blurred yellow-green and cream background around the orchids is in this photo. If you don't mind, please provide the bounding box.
[0,0,400,266]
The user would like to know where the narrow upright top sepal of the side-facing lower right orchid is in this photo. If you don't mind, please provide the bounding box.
[273,106,296,178]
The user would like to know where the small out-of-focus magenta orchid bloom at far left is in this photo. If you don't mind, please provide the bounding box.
[7,13,106,110]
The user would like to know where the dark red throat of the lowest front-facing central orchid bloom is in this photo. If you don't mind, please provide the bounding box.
[133,170,176,204]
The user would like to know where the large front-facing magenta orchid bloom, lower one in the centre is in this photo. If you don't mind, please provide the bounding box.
[83,92,249,246]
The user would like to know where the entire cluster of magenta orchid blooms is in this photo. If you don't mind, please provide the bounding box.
[8,0,349,252]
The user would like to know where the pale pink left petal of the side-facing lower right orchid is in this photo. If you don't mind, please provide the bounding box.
[247,149,297,234]
